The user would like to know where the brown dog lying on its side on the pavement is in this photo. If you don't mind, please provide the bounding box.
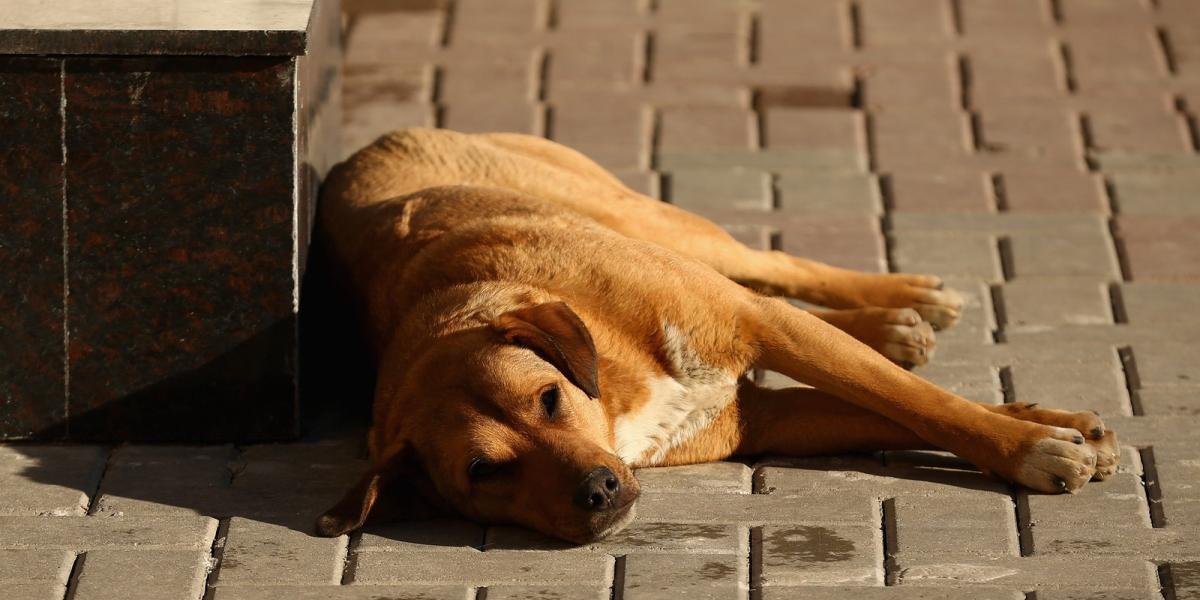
[317,130,1117,542]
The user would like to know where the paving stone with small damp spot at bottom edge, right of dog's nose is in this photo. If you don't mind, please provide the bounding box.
[624,554,750,600]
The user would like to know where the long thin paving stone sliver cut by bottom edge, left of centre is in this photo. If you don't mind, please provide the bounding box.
[212,586,472,600]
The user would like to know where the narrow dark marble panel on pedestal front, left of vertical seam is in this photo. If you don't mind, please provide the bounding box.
[0,58,66,436]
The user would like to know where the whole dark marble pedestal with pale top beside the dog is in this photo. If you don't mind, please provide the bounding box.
[0,0,341,442]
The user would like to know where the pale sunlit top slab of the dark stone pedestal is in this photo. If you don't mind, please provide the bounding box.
[0,0,317,56]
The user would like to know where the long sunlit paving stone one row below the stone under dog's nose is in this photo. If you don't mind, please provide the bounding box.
[354,550,612,586]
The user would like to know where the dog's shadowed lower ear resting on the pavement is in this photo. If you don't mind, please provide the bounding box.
[317,450,446,538]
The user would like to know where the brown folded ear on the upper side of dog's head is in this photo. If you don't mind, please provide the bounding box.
[496,302,600,398]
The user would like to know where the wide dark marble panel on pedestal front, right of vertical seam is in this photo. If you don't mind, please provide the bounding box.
[65,58,296,440]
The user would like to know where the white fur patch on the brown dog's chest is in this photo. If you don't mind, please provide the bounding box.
[614,324,737,467]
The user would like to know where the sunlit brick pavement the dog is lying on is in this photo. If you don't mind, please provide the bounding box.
[0,0,1200,600]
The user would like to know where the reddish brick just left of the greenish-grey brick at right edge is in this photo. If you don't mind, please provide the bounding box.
[1003,169,1109,214]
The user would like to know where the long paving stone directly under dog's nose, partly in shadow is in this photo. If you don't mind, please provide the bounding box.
[485,521,749,556]
